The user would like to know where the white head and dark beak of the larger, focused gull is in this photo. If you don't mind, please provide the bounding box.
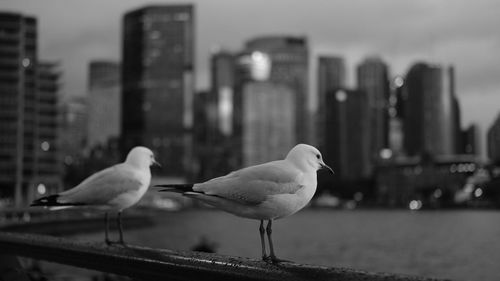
[286,144,333,174]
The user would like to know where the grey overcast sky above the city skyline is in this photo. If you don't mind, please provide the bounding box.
[0,0,500,158]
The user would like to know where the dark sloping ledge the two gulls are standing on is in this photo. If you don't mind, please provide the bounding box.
[0,232,452,281]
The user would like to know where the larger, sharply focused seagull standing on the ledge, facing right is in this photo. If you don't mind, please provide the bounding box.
[155,144,333,263]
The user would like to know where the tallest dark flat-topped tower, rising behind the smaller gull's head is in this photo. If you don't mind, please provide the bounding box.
[121,5,194,176]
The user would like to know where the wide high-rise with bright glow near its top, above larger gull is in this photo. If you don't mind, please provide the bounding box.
[231,36,308,165]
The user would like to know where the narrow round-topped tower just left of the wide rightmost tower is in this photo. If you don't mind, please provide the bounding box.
[357,57,390,160]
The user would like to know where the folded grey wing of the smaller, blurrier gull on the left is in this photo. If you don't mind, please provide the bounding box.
[58,163,143,205]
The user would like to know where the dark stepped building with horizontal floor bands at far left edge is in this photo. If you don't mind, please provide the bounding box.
[0,12,62,203]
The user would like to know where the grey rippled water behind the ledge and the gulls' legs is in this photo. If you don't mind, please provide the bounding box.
[73,209,500,281]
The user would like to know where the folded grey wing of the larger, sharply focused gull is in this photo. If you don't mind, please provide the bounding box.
[193,160,303,205]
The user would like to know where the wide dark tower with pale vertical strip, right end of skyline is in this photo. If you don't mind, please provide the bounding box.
[404,63,456,156]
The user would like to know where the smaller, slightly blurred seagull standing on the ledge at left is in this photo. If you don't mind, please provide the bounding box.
[30,146,159,245]
